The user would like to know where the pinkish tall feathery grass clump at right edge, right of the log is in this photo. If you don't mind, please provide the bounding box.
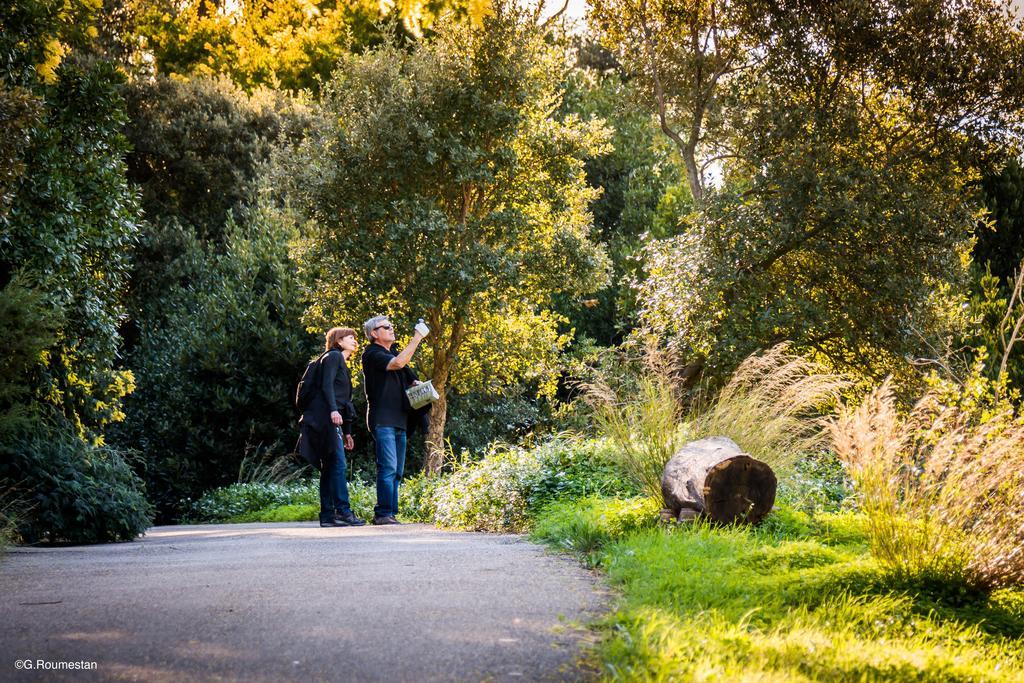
[829,381,1024,590]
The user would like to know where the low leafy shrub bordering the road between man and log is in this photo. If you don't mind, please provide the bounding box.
[402,436,639,531]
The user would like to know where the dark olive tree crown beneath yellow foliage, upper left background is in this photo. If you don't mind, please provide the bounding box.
[119,76,308,356]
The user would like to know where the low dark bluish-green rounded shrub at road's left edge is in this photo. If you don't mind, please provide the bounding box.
[0,421,153,543]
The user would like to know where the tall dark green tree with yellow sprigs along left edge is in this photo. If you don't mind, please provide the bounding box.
[0,3,138,438]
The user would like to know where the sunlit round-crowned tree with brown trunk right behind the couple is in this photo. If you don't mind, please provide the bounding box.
[281,6,606,468]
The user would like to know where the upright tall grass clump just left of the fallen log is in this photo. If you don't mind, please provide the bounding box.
[583,346,684,500]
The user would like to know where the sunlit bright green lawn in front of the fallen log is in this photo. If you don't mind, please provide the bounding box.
[535,499,1024,681]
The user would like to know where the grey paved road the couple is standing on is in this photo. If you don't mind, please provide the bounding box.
[0,523,605,681]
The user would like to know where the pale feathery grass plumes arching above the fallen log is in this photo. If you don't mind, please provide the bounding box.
[687,343,849,472]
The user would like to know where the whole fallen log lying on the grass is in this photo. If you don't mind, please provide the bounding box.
[662,436,778,524]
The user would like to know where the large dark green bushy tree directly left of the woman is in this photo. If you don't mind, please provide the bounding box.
[116,209,316,519]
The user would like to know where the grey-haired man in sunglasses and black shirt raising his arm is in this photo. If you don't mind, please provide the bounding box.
[362,315,430,524]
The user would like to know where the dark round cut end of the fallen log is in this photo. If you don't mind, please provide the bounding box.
[702,455,778,524]
